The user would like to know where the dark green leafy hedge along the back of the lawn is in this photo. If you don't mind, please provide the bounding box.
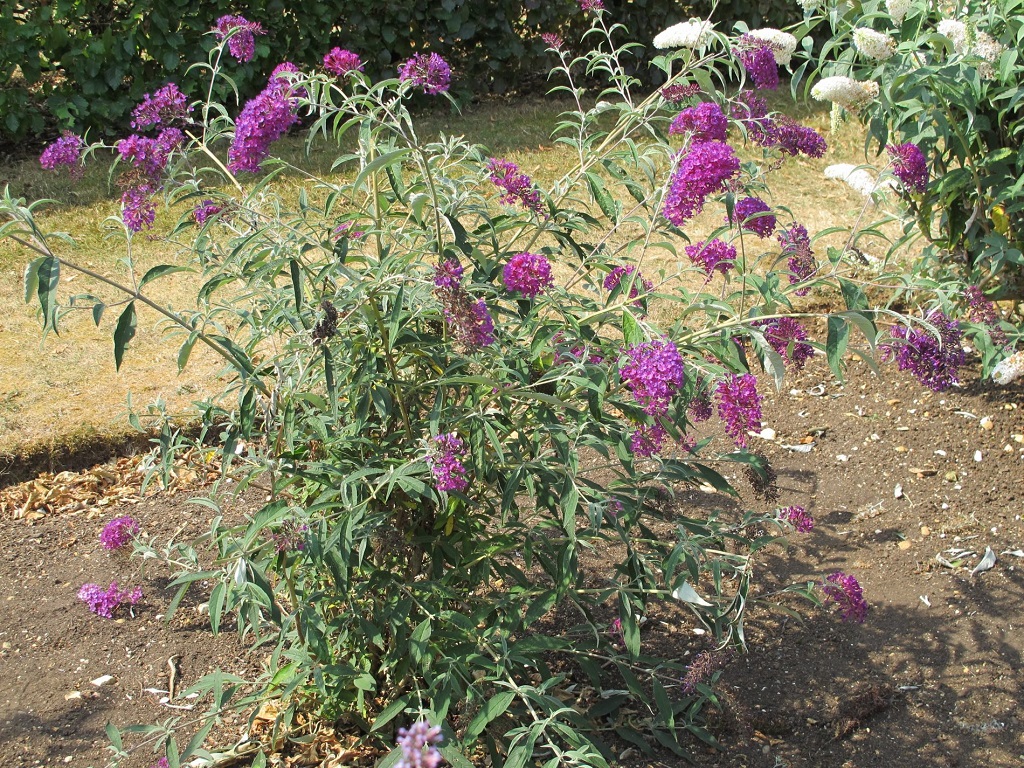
[0,0,796,142]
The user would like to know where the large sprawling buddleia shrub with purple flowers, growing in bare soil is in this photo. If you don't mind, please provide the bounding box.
[0,6,901,766]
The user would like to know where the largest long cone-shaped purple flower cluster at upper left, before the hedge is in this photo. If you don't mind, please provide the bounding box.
[227,72,299,173]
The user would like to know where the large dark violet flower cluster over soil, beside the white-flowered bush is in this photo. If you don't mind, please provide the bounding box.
[886,309,967,392]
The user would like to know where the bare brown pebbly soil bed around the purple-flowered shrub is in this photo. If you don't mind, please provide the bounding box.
[0,362,1024,768]
